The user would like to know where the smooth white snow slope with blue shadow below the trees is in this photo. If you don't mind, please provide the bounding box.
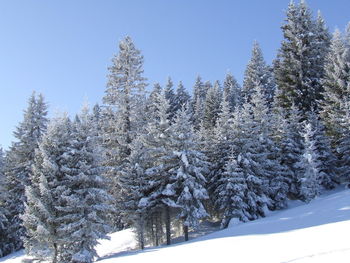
[0,189,350,263]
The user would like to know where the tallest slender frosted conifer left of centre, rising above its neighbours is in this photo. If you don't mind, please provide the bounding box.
[103,37,146,228]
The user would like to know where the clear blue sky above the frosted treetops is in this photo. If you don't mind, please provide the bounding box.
[0,0,350,148]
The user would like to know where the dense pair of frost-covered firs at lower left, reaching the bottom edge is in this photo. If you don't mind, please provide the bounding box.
[22,113,110,263]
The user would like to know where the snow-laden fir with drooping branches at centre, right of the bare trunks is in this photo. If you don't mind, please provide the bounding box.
[168,107,208,241]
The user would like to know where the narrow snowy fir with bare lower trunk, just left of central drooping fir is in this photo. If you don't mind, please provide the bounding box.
[139,92,177,248]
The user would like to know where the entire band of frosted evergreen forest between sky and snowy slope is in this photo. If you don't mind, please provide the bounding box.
[0,1,350,263]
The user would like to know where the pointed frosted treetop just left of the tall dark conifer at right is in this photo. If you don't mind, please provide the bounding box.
[242,42,275,104]
